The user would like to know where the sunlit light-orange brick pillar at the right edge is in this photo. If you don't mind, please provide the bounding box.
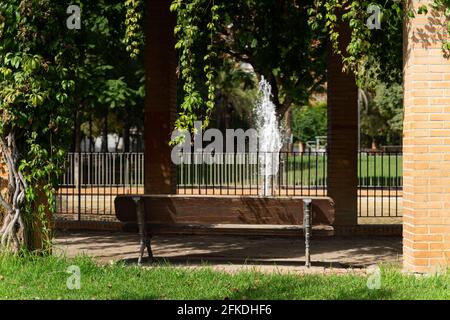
[403,0,450,272]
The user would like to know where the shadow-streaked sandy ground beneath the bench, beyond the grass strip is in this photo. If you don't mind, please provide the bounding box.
[55,232,402,273]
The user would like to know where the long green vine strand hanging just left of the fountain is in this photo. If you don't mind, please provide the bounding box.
[170,0,219,131]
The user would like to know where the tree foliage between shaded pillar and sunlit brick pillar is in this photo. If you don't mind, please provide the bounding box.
[357,2,403,148]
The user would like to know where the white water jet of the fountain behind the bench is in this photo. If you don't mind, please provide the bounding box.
[254,77,282,196]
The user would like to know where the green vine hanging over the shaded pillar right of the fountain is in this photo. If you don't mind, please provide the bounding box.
[310,0,403,76]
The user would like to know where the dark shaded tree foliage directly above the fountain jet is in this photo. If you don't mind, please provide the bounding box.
[217,0,326,122]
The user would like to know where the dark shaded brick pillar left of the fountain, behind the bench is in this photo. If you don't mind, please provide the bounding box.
[144,0,177,194]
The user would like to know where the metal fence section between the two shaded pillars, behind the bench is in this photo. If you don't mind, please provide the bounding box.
[177,152,326,196]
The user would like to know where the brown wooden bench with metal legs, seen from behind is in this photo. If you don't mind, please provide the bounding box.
[114,195,334,267]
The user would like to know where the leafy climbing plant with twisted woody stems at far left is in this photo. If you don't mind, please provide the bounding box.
[0,0,144,252]
